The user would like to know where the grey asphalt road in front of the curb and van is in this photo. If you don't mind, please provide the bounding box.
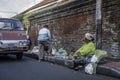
[0,56,119,80]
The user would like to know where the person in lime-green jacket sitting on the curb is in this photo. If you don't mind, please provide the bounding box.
[73,33,95,69]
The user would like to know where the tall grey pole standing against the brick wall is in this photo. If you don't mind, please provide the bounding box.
[96,0,102,49]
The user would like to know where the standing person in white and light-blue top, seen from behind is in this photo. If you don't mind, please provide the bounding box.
[38,25,51,61]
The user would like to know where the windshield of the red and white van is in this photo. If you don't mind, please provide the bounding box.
[0,19,24,30]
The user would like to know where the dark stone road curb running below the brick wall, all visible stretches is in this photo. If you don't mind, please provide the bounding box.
[24,54,120,78]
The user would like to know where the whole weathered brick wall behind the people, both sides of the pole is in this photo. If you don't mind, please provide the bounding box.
[30,0,120,54]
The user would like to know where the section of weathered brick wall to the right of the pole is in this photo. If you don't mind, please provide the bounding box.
[103,0,120,55]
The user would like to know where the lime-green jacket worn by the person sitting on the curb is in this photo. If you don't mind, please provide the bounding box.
[78,42,95,56]
